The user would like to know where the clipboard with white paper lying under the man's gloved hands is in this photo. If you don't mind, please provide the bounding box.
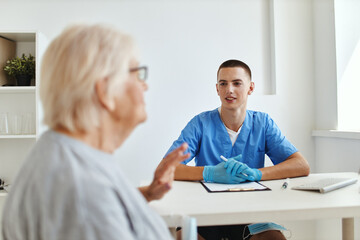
[200,181,271,193]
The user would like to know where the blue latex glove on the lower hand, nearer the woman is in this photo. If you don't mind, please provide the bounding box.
[203,162,246,184]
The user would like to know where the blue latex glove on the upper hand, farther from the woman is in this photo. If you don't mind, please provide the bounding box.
[224,154,262,181]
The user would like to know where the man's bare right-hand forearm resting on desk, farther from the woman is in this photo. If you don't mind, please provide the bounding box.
[259,152,310,180]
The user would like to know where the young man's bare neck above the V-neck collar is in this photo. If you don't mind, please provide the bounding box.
[220,107,246,132]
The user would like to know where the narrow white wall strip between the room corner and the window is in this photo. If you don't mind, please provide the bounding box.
[313,0,337,129]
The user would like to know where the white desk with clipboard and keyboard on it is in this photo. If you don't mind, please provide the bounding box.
[150,173,360,240]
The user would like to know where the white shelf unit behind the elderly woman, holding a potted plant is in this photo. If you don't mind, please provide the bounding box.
[0,30,46,186]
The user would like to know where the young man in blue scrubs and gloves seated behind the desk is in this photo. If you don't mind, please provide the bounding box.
[168,60,310,240]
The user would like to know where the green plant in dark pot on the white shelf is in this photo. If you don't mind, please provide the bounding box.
[4,54,35,86]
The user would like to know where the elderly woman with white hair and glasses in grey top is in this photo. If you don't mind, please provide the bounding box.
[2,25,189,240]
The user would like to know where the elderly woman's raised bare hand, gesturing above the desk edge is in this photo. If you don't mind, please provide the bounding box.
[139,143,190,202]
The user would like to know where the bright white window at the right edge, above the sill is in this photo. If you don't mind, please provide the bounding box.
[334,0,360,131]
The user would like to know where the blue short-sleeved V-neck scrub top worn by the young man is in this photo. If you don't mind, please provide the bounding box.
[166,109,298,168]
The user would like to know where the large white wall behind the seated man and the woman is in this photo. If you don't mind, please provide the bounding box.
[0,0,314,185]
